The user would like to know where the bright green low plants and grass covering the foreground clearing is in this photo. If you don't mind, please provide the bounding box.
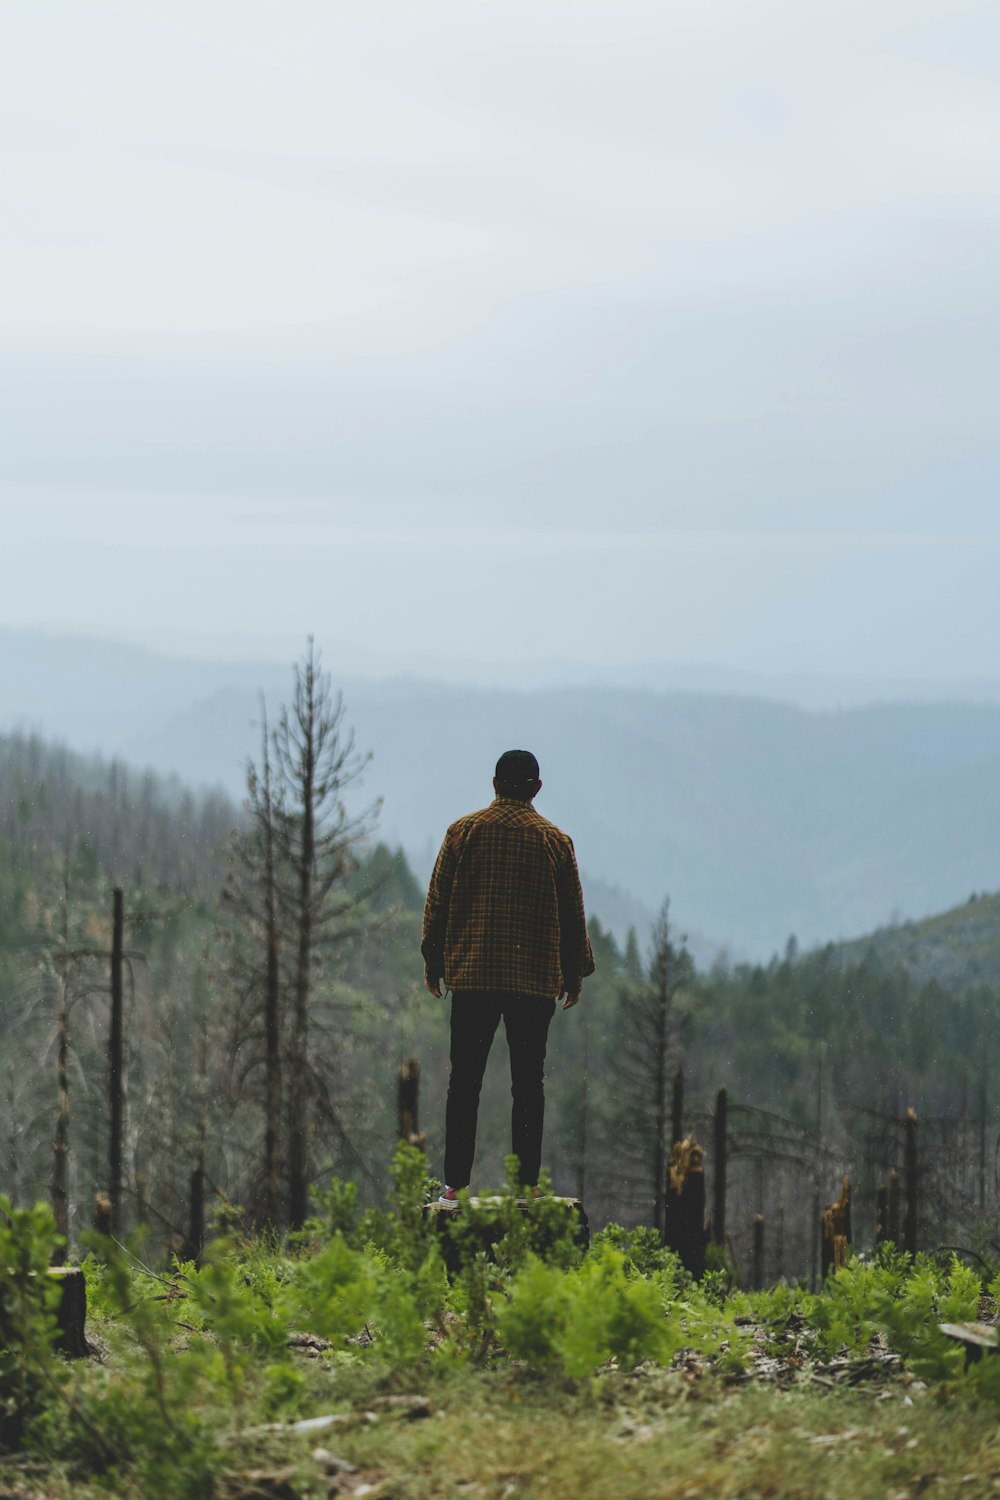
[0,1146,1000,1500]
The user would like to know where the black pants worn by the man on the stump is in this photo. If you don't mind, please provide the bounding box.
[444,990,556,1188]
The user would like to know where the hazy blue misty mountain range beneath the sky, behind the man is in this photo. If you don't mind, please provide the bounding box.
[0,632,1000,959]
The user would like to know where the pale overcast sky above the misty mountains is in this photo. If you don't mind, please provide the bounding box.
[0,0,1000,678]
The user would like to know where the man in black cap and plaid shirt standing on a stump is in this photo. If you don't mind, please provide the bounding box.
[420,750,594,1203]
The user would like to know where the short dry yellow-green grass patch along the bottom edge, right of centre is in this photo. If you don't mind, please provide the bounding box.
[283,1371,1000,1500]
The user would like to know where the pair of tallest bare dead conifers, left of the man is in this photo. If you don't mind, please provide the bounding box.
[223,639,378,1227]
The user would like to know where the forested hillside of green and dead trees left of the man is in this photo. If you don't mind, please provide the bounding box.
[0,651,434,1250]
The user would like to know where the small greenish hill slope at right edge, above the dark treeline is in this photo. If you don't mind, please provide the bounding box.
[835,894,1000,993]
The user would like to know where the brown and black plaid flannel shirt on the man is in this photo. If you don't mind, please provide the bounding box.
[420,797,594,998]
